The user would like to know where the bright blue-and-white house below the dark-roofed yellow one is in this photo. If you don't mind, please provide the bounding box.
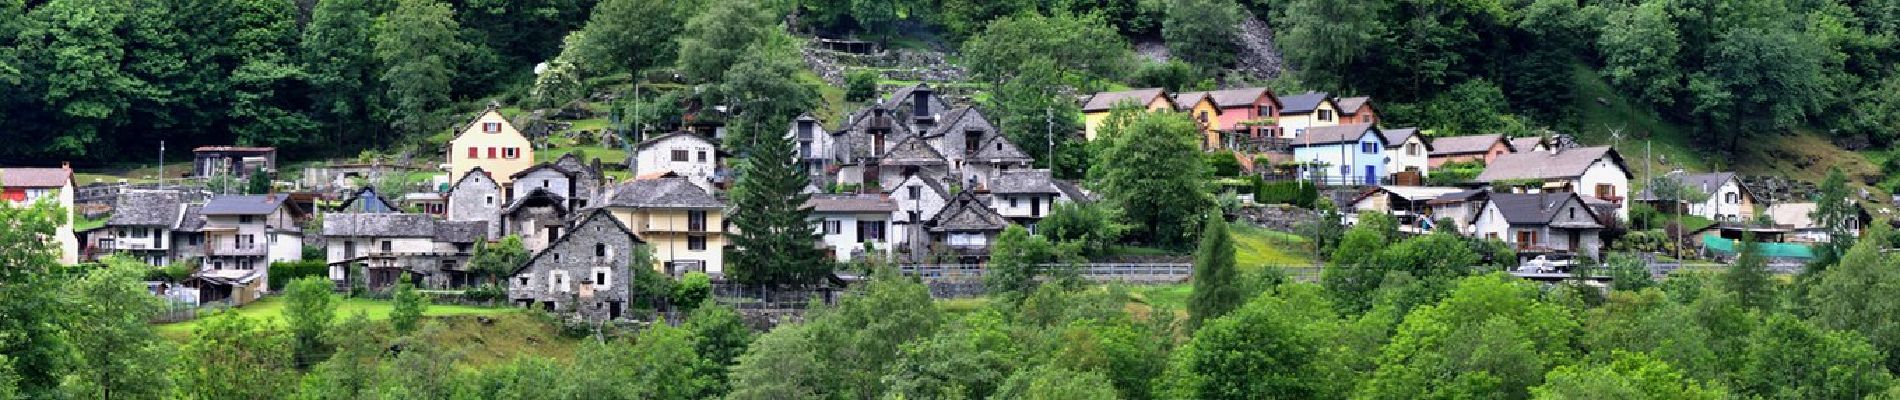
[1292,123,1391,184]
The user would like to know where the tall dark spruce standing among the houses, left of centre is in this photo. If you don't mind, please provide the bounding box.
[730,123,830,284]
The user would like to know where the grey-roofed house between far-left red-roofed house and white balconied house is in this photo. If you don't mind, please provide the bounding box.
[96,190,190,265]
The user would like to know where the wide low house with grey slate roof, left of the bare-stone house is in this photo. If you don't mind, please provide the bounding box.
[323,212,486,290]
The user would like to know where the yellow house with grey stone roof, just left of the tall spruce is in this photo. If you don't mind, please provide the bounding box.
[604,174,726,277]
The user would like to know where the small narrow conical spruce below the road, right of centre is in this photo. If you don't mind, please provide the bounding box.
[1188,214,1246,328]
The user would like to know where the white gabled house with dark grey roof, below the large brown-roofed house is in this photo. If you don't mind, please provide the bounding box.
[1473,191,1604,258]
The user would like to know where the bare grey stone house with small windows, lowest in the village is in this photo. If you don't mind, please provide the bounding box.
[507,209,646,320]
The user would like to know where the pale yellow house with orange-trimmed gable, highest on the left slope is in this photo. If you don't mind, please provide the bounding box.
[448,106,534,188]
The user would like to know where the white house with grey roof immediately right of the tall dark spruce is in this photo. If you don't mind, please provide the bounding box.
[804,193,897,262]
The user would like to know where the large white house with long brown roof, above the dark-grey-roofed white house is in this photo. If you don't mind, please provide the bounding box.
[1476,146,1632,220]
